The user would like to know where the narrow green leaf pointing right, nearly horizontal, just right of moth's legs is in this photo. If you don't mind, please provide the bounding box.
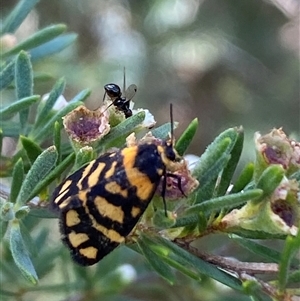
[186,189,263,214]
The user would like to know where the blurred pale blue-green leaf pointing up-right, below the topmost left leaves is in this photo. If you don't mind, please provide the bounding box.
[29,33,77,61]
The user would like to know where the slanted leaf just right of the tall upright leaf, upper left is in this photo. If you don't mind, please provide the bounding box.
[34,78,66,129]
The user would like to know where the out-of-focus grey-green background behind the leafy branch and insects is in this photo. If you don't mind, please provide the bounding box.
[0,0,300,301]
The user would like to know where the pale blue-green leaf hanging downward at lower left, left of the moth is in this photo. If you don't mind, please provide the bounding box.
[10,220,38,284]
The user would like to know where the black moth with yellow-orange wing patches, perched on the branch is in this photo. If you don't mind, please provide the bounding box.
[52,142,181,265]
